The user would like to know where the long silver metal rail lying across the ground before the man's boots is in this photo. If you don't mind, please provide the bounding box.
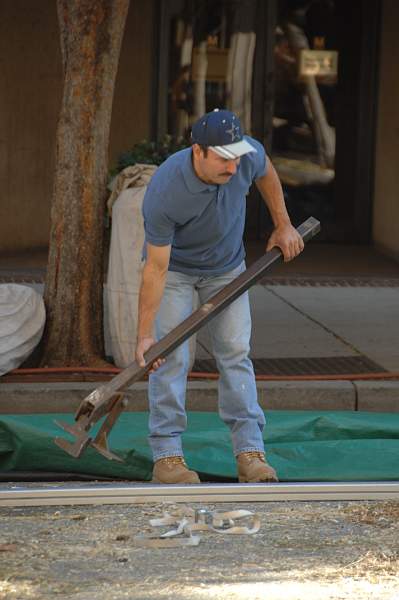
[0,481,399,507]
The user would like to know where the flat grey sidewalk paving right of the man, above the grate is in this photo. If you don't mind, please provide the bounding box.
[250,280,399,372]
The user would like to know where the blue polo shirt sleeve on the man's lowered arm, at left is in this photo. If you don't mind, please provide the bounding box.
[143,187,175,246]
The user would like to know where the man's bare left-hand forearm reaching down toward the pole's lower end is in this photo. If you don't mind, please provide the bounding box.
[137,263,167,339]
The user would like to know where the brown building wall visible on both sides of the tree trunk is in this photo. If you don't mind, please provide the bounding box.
[0,0,153,255]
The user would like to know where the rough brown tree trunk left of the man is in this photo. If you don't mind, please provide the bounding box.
[41,0,129,366]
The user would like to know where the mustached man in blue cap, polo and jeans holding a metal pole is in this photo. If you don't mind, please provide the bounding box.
[136,109,303,483]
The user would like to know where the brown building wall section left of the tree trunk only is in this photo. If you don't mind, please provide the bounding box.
[0,0,61,251]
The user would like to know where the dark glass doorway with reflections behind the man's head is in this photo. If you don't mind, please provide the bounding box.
[154,0,380,243]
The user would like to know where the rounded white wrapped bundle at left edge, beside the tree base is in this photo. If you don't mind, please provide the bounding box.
[0,283,46,375]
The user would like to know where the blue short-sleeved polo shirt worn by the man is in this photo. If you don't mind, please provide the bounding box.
[143,136,266,276]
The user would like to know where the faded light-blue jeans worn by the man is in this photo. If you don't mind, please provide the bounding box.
[148,263,265,460]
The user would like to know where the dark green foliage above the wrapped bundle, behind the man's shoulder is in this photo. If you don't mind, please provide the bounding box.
[111,135,189,176]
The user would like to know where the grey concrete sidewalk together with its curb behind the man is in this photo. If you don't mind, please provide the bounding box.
[0,277,399,414]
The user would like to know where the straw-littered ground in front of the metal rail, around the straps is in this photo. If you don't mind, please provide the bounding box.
[0,501,399,600]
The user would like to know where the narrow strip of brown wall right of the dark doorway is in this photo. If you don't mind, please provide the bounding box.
[373,0,399,261]
